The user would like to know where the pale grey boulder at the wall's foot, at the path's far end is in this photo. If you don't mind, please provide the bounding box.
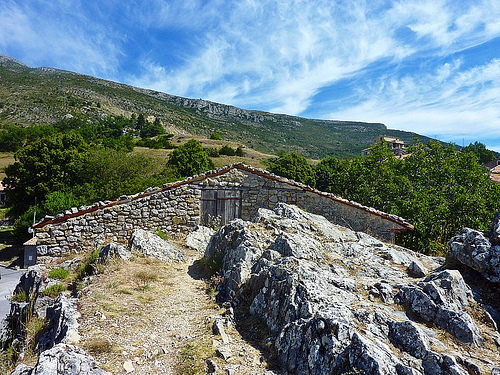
[128,229,186,262]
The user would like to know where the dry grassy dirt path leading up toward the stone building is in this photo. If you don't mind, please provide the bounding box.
[79,250,276,374]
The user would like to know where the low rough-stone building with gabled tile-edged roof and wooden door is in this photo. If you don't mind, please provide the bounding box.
[33,163,413,255]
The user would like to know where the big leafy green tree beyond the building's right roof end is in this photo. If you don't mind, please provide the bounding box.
[398,142,500,254]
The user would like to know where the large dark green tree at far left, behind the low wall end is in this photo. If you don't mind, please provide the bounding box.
[4,132,89,214]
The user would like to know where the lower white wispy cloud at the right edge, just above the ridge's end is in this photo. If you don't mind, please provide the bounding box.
[324,59,500,147]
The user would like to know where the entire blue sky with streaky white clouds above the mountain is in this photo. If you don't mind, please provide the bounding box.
[0,0,500,151]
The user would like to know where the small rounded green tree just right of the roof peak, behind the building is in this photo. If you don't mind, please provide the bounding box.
[268,152,315,186]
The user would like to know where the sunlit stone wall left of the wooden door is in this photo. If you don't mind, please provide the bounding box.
[36,185,201,255]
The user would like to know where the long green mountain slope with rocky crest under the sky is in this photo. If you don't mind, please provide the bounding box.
[0,56,429,158]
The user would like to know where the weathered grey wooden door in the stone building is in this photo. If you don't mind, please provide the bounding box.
[200,189,241,225]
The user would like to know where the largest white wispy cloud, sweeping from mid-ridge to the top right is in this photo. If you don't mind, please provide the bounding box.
[128,0,500,114]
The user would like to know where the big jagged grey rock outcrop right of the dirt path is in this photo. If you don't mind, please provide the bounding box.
[205,204,500,375]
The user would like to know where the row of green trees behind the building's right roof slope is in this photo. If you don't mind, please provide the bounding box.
[268,141,500,255]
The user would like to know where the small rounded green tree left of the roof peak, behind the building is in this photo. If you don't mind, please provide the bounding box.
[167,139,214,177]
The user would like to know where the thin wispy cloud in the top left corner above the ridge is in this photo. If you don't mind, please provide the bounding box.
[0,0,122,76]
